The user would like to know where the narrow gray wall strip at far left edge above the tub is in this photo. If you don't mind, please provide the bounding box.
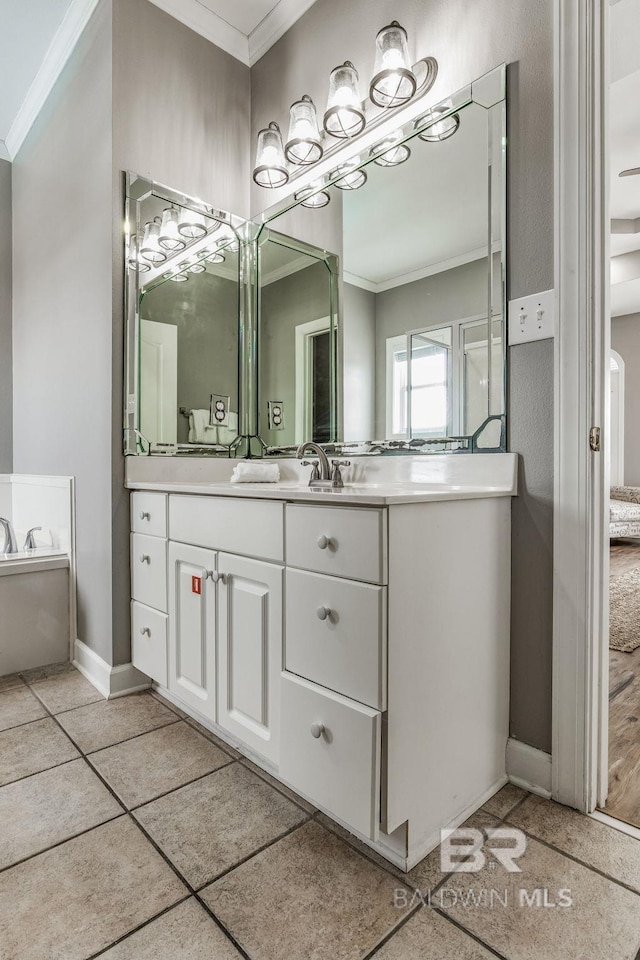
[0,160,13,473]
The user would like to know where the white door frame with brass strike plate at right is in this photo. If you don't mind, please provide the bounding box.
[552,0,609,813]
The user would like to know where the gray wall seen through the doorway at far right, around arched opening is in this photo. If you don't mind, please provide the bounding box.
[611,313,640,487]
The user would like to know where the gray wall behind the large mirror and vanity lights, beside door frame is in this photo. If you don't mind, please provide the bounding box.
[251,0,553,750]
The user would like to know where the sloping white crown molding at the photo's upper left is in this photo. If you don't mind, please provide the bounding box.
[5,0,98,160]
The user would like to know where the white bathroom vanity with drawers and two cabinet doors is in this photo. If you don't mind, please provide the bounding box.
[128,454,516,869]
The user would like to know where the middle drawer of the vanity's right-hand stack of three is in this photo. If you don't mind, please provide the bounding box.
[285,570,387,710]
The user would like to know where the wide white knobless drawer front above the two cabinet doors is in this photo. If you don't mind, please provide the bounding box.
[169,494,284,561]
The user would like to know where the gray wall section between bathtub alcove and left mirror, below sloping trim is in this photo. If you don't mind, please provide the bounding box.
[13,0,114,662]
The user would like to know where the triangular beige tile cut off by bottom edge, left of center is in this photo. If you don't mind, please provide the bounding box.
[100,899,241,960]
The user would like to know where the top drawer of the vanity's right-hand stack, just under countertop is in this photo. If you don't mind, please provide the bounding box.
[286,504,387,583]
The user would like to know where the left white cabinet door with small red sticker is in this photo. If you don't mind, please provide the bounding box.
[169,542,216,720]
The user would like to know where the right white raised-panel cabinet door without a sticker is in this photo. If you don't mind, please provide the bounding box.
[218,553,283,764]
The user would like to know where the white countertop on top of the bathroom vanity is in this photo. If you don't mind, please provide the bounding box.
[127,480,515,506]
